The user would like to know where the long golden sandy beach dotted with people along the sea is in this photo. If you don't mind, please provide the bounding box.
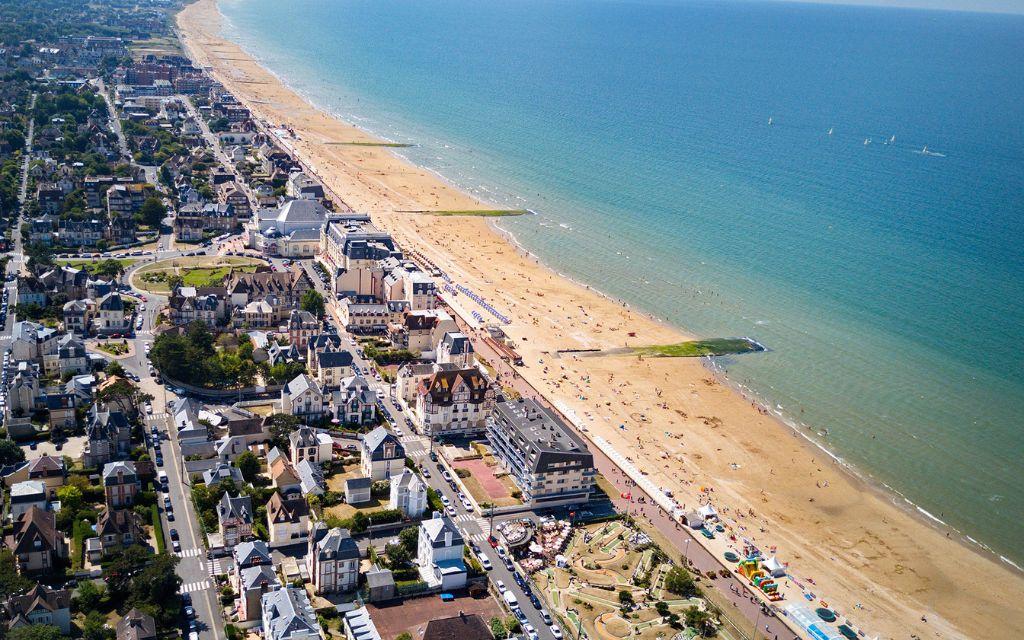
[178,0,1024,639]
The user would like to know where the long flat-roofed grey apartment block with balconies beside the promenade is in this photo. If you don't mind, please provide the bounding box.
[487,398,596,508]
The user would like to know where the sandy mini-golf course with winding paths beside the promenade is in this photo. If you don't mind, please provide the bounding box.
[532,520,726,640]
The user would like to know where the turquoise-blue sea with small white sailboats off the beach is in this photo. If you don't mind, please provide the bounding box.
[220,0,1024,561]
